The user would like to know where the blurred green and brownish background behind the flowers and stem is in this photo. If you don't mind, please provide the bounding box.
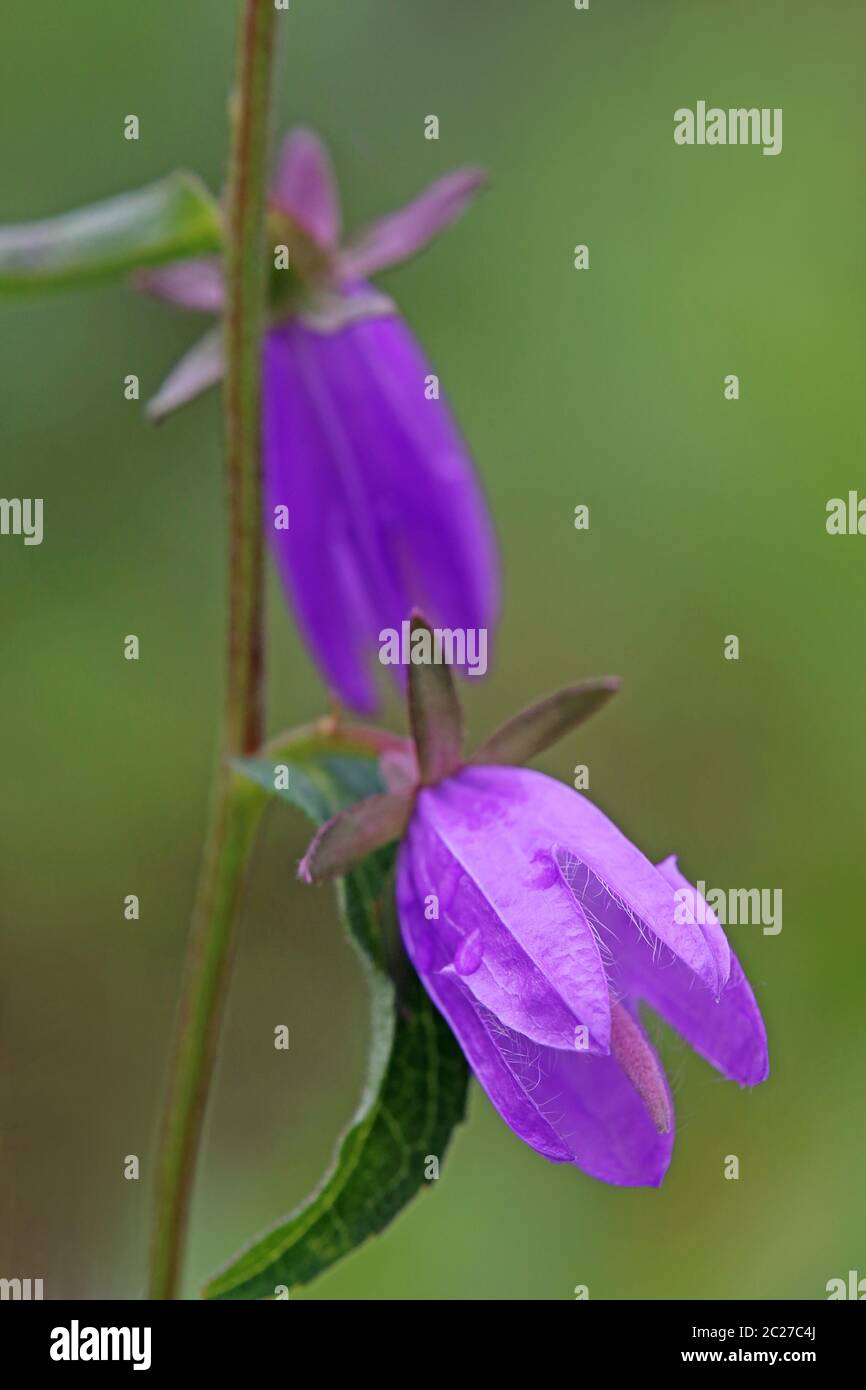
[0,0,866,1300]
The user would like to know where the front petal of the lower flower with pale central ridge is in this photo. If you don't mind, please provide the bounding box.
[400,773,610,1051]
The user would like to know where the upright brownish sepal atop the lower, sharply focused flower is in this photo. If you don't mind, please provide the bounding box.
[409,613,463,784]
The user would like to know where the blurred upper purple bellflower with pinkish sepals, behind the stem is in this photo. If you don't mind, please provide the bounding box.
[138,129,499,712]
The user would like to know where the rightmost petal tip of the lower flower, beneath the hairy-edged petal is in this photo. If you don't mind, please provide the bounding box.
[608,860,769,1086]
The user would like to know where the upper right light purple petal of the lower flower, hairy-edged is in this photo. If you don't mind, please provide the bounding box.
[436,767,719,991]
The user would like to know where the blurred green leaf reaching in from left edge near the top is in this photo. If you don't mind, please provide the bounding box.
[0,172,222,295]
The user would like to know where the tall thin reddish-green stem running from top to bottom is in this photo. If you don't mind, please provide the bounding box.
[150,0,277,1298]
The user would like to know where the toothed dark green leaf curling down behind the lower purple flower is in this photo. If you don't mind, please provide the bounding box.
[204,753,468,1298]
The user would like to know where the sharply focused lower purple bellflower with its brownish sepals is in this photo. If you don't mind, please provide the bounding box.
[300,619,769,1187]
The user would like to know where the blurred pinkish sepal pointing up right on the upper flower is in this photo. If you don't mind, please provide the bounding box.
[339,168,487,279]
